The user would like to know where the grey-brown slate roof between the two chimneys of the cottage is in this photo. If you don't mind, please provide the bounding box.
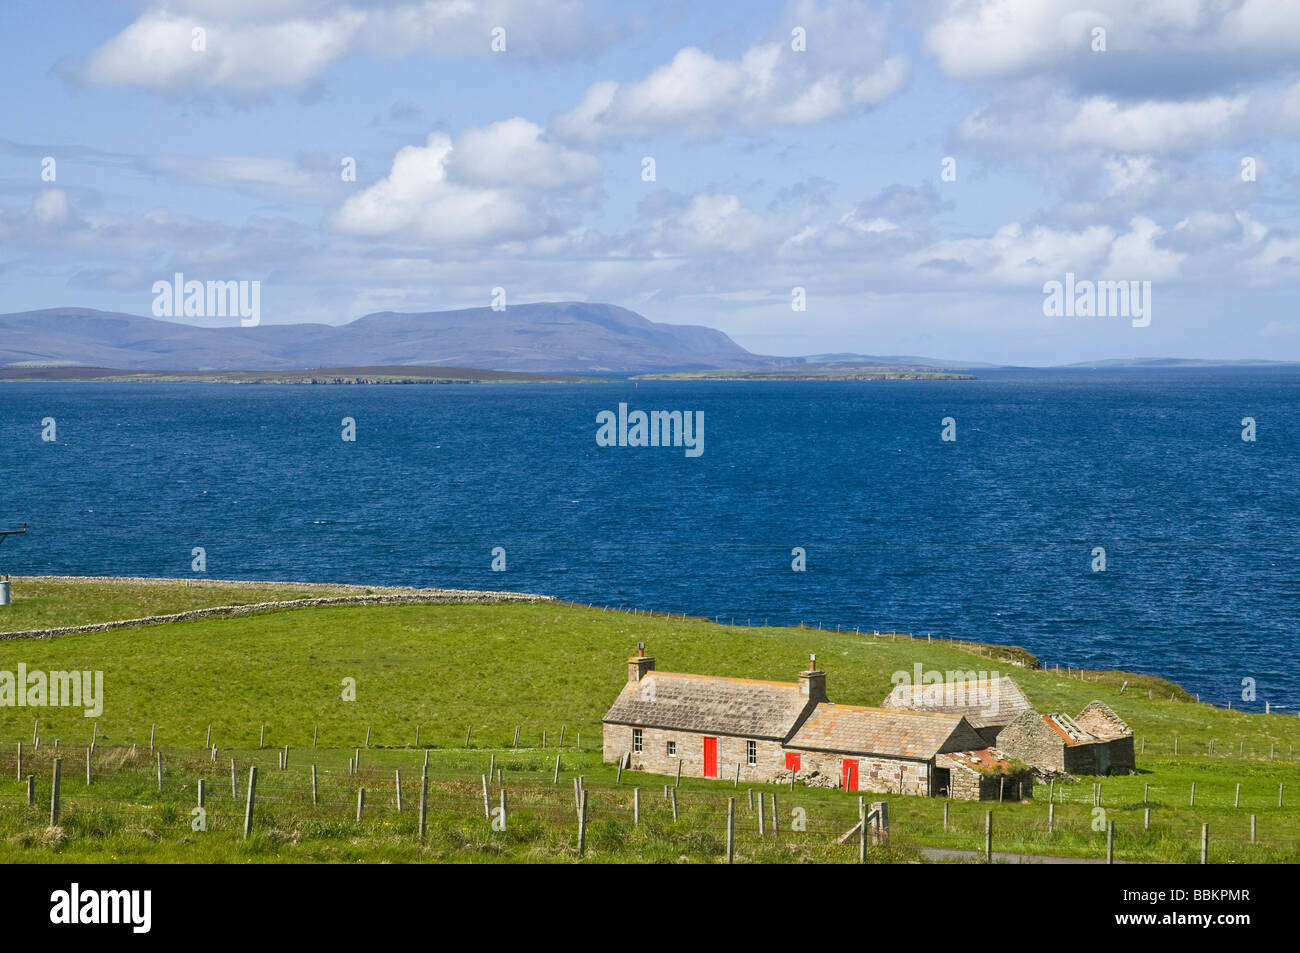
[605,672,813,741]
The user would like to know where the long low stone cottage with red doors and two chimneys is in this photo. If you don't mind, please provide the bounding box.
[605,647,1034,798]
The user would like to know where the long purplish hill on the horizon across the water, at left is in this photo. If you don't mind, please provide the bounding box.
[0,302,769,374]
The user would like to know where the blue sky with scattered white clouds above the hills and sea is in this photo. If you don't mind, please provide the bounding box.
[0,0,1300,364]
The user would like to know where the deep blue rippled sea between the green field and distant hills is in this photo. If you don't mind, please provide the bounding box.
[0,368,1300,714]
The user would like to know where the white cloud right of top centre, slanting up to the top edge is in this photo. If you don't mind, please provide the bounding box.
[551,0,906,143]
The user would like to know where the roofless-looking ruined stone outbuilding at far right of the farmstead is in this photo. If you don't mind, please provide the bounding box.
[998,701,1136,775]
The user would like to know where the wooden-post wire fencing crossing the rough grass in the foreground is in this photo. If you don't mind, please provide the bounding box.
[0,744,1300,862]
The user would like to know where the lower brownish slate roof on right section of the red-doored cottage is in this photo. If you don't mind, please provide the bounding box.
[785,702,988,761]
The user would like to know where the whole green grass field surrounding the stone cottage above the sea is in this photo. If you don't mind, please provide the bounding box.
[0,581,1300,862]
